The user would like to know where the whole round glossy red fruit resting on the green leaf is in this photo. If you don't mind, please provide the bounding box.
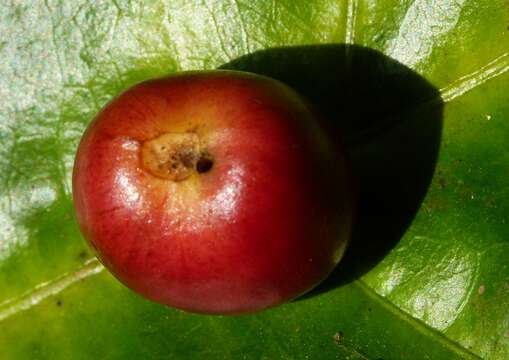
[73,71,352,314]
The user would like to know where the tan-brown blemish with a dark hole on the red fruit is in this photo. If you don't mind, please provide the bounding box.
[141,132,213,182]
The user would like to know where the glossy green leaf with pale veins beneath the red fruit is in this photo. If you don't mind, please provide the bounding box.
[0,0,509,359]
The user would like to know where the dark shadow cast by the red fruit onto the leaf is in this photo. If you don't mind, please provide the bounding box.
[221,45,443,297]
